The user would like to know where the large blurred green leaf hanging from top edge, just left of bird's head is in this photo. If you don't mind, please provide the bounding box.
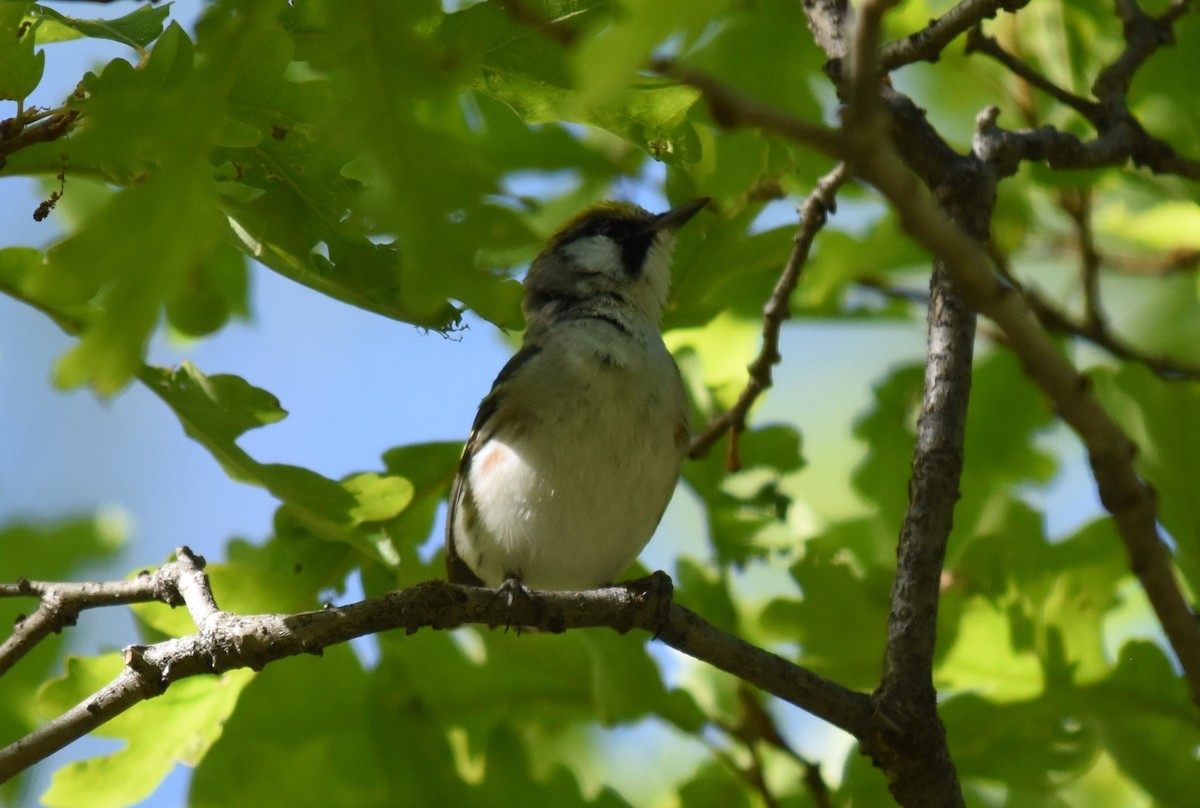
[296,4,520,328]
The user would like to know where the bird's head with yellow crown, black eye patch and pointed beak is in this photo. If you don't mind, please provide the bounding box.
[524,198,708,323]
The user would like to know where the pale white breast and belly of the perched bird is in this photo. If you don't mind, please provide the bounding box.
[456,319,688,589]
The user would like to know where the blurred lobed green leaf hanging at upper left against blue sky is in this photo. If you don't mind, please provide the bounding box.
[17,26,231,394]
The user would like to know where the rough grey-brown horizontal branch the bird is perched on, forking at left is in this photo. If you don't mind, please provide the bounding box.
[0,547,871,783]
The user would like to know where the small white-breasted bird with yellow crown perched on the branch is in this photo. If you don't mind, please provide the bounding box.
[445,198,709,588]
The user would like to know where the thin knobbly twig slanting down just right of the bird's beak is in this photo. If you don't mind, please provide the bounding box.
[688,163,848,471]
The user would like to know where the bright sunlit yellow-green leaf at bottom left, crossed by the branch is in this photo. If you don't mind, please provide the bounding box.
[38,654,254,808]
